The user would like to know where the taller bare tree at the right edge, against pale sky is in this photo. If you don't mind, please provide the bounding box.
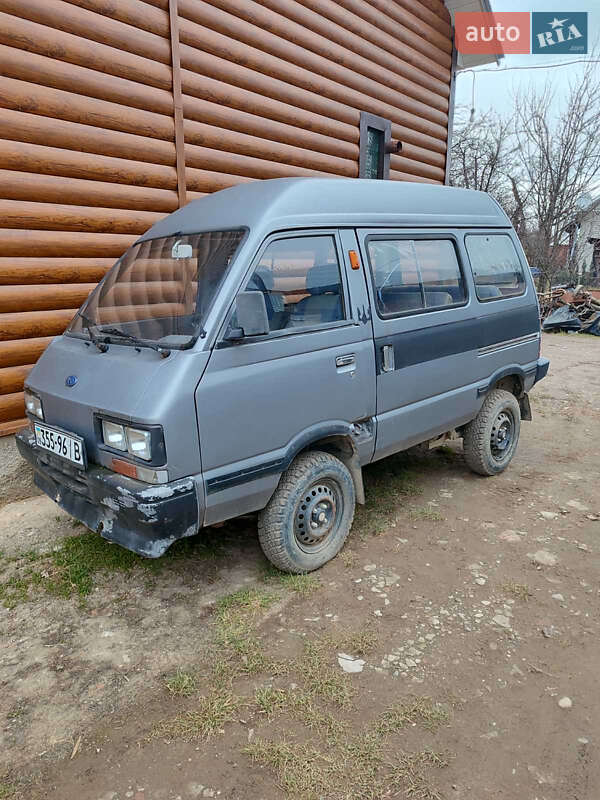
[512,65,600,288]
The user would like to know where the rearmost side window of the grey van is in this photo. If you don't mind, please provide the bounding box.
[465,238,525,301]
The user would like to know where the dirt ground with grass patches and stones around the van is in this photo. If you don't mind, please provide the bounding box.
[0,335,600,800]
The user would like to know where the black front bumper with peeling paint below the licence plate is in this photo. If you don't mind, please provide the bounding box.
[16,428,200,558]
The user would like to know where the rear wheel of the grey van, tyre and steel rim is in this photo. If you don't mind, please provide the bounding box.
[463,389,521,476]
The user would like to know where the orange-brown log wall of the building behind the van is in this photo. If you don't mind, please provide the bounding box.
[0,0,452,435]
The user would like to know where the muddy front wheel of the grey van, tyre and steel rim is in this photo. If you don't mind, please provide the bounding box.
[258,450,355,573]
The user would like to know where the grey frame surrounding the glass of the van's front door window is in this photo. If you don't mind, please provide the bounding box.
[217,228,354,348]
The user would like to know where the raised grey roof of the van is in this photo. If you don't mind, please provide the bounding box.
[141,178,510,240]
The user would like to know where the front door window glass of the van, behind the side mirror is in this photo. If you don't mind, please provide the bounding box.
[246,236,346,331]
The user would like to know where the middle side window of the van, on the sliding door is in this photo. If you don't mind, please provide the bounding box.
[367,239,466,317]
